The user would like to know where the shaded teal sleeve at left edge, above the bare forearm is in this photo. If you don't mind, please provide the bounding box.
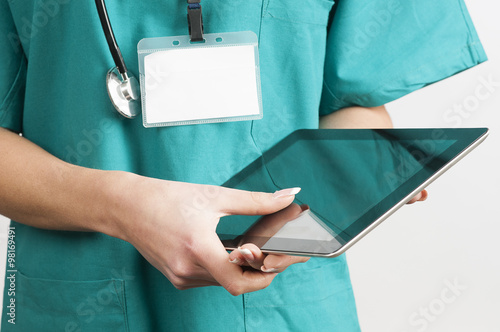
[0,0,27,133]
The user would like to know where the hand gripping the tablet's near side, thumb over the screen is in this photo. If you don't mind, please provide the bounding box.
[114,177,304,295]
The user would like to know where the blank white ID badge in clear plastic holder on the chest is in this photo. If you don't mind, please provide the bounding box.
[137,31,262,127]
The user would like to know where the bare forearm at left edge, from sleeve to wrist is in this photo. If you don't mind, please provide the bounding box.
[0,128,127,239]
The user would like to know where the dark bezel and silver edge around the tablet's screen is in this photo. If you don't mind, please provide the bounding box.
[219,128,488,257]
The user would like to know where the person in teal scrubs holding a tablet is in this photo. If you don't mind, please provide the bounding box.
[0,0,486,331]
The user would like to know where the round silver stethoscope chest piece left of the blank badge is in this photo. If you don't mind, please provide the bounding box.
[106,67,141,119]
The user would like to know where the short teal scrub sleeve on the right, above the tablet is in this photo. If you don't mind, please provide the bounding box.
[320,0,487,115]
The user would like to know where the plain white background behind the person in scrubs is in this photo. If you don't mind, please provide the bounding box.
[0,0,500,332]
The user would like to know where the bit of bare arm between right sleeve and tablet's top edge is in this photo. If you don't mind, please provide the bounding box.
[319,106,392,129]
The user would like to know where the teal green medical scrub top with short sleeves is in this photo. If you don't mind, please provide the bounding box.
[0,0,486,332]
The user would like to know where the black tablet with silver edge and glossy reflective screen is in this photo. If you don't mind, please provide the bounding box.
[217,128,488,257]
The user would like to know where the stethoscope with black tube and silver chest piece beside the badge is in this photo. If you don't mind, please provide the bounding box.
[95,0,141,118]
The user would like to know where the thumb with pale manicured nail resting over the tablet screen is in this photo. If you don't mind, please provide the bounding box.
[216,188,300,216]
